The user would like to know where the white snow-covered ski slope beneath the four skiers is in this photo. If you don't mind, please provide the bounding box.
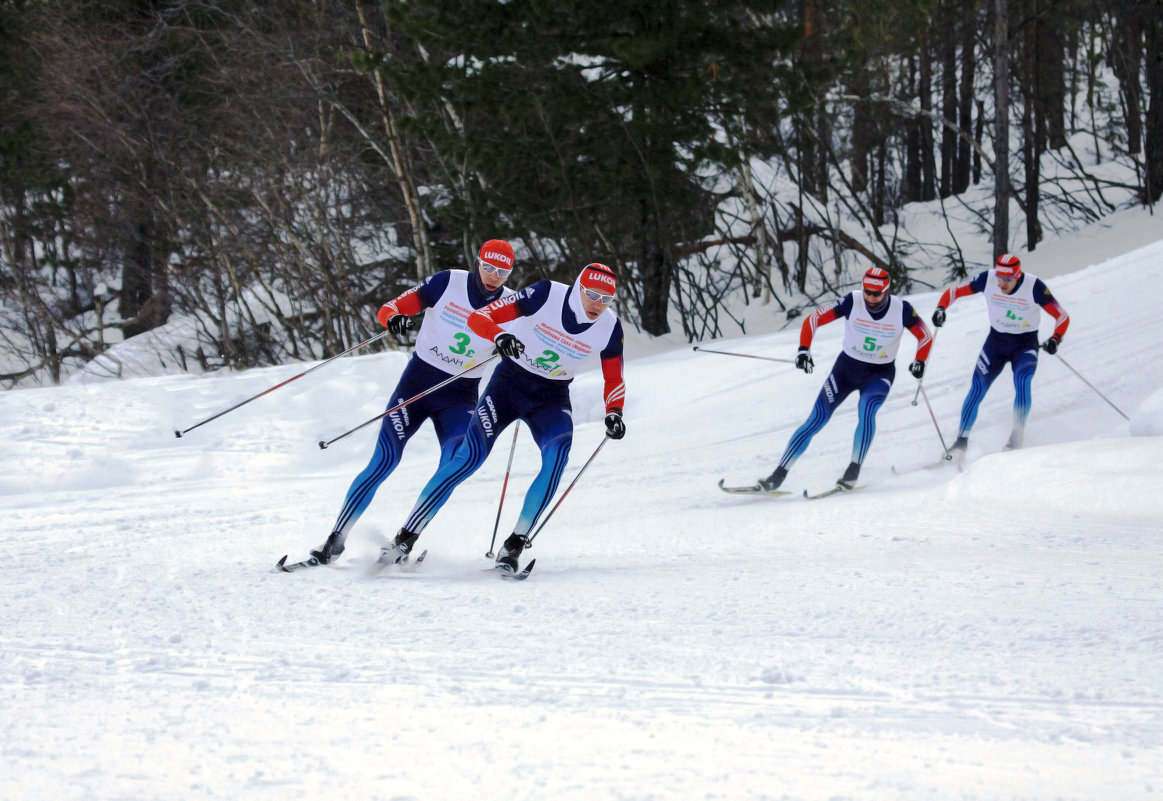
[0,219,1163,801]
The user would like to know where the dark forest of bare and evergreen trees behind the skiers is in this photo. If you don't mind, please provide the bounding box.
[0,0,1163,387]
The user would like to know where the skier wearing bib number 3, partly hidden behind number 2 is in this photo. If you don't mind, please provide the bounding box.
[311,239,514,565]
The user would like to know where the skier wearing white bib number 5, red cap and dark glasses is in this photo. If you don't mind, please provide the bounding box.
[759,267,933,492]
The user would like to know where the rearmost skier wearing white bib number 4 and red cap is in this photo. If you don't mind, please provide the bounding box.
[933,253,1070,455]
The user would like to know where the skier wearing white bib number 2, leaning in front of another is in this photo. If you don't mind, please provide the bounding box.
[380,264,626,572]
